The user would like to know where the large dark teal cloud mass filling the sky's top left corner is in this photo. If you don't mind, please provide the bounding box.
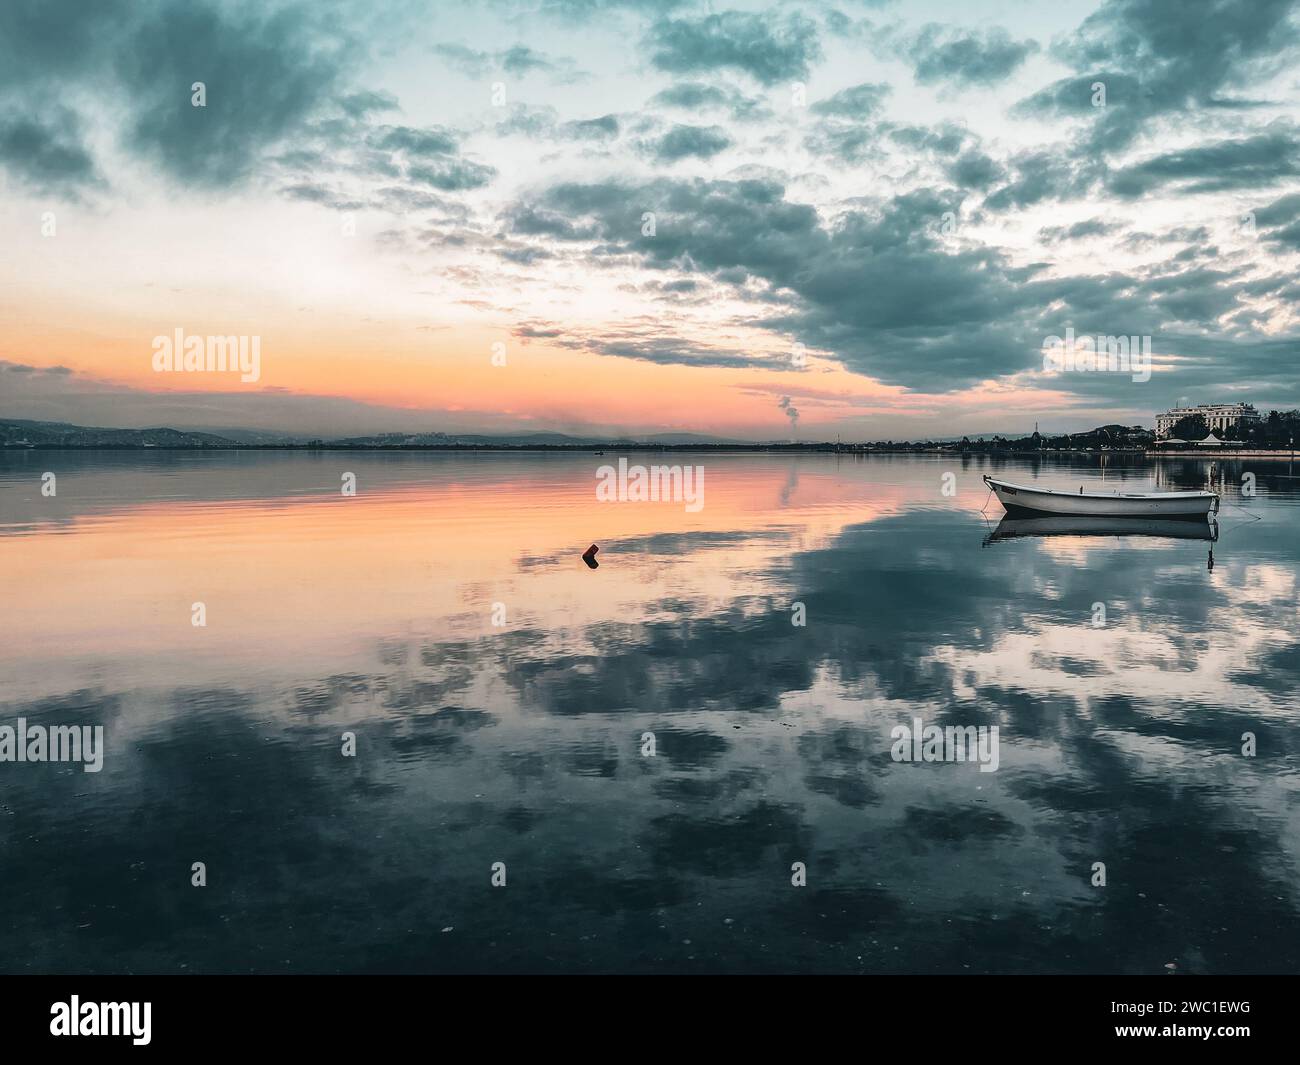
[0,0,506,201]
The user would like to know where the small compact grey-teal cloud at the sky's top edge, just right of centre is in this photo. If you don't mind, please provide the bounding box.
[645,12,822,86]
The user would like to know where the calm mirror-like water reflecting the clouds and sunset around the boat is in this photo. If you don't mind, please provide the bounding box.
[0,453,1300,973]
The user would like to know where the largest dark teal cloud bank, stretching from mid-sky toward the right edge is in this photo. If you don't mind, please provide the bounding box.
[506,172,1300,393]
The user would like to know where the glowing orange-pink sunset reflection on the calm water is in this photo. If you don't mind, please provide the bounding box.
[0,455,917,694]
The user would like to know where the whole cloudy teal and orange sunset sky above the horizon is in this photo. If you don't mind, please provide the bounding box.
[0,0,1300,440]
